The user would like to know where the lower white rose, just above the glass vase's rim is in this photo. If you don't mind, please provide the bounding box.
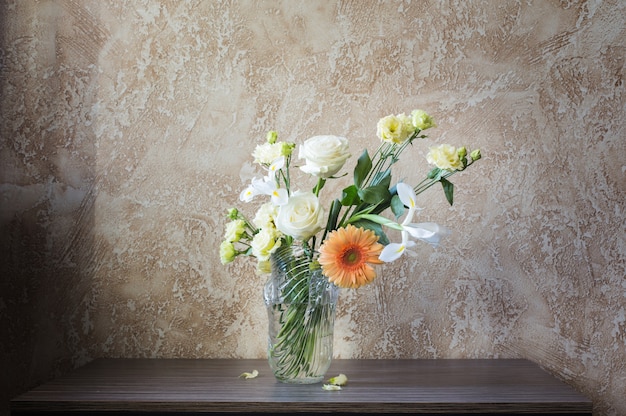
[275,191,324,241]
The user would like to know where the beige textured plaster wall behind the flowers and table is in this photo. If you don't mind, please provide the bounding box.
[0,0,626,415]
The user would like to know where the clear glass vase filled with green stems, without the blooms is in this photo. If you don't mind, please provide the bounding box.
[264,246,339,384]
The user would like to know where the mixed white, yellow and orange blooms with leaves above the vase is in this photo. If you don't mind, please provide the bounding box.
[220,110,481,288]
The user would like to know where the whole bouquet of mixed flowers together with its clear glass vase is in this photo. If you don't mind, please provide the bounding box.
[220,110,480,383]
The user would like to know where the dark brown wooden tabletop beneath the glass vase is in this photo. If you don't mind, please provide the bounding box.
[11,359,592,415]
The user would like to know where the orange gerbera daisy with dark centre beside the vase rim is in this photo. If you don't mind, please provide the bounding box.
[318,225,383,289]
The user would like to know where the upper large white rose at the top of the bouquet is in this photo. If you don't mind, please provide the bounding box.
[298,136,350,178]
